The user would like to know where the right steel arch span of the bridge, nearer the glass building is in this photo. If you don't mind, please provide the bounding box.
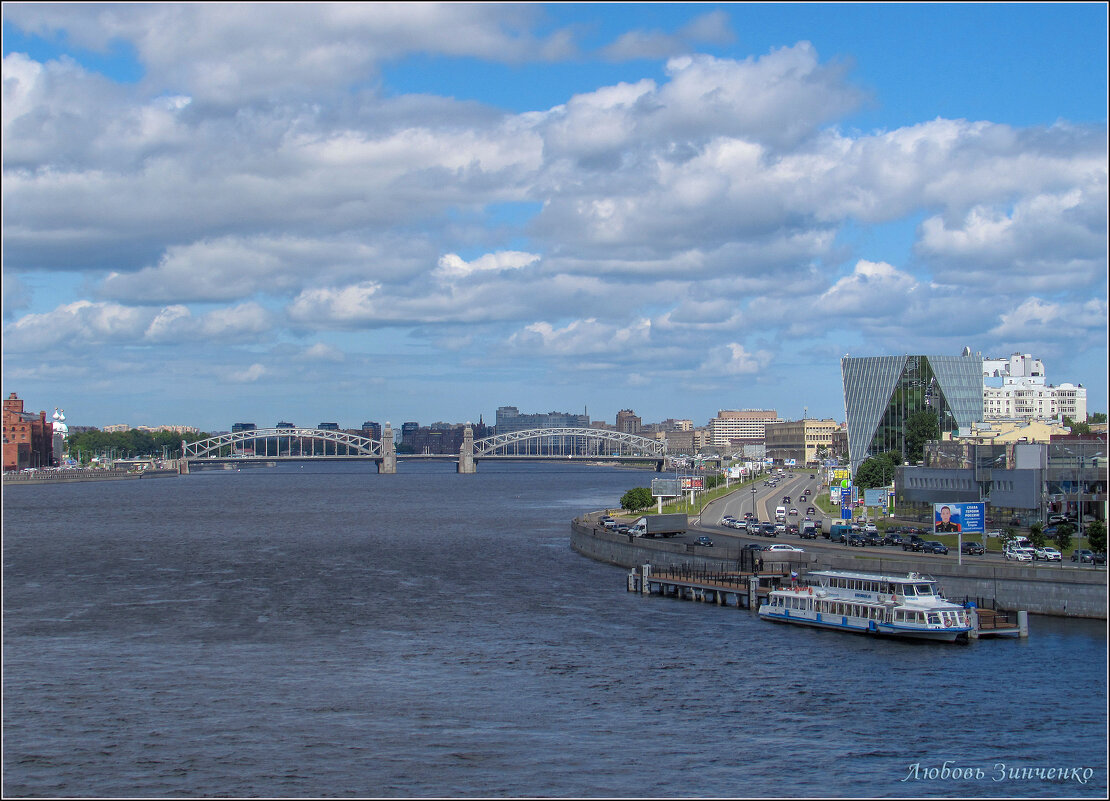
[474,427,667,460]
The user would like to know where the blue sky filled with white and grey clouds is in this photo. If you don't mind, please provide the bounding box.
[2,3,1108,430]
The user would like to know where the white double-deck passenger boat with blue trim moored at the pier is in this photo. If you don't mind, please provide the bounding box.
[759,570,971,641]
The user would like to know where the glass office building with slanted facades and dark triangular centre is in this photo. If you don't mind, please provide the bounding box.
[840,351,982,475]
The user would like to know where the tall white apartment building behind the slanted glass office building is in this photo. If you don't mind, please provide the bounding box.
[982,353,1087,422]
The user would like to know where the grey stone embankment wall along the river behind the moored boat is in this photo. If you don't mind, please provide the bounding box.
[571,519,1107,620]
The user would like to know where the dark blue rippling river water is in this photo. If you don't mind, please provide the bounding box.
[3,462,1107,798]
